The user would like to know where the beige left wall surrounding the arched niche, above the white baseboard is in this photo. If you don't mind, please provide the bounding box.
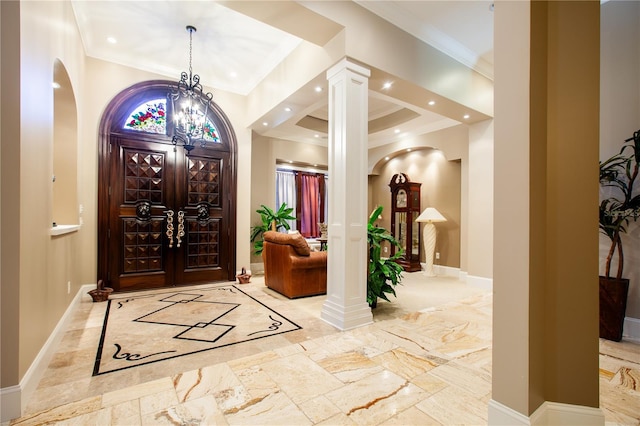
[18,2,84,386]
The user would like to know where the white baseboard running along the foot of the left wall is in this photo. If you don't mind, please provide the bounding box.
[0,284,96,423]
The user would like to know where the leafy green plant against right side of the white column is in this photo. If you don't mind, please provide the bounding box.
[367,206,404,308]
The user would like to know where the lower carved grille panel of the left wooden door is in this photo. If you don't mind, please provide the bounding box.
[122,218,164,274]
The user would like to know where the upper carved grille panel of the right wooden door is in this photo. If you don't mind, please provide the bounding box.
[188,157,221,207]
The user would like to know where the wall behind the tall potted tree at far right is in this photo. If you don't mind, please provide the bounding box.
[600,1,640,320]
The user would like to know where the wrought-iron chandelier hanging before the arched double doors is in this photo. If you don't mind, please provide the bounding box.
[168,25,213,152]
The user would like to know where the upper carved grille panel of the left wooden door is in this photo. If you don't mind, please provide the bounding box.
[123,148,165,204]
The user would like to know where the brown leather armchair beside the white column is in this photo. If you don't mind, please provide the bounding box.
[262,231,327,299]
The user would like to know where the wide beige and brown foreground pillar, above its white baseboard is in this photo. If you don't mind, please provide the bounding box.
[490,2,599,414]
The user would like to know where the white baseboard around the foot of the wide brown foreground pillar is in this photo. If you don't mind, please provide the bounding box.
[488,399,604,426]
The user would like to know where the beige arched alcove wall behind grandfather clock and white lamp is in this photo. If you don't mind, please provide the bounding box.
[369,148,461,268]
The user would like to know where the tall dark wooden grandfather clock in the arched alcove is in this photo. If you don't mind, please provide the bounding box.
[389,173,422,272]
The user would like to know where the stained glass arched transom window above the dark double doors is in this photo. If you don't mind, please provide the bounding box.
[122,98,220,143]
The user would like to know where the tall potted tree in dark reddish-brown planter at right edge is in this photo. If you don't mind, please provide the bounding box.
[599,130,640,341]
